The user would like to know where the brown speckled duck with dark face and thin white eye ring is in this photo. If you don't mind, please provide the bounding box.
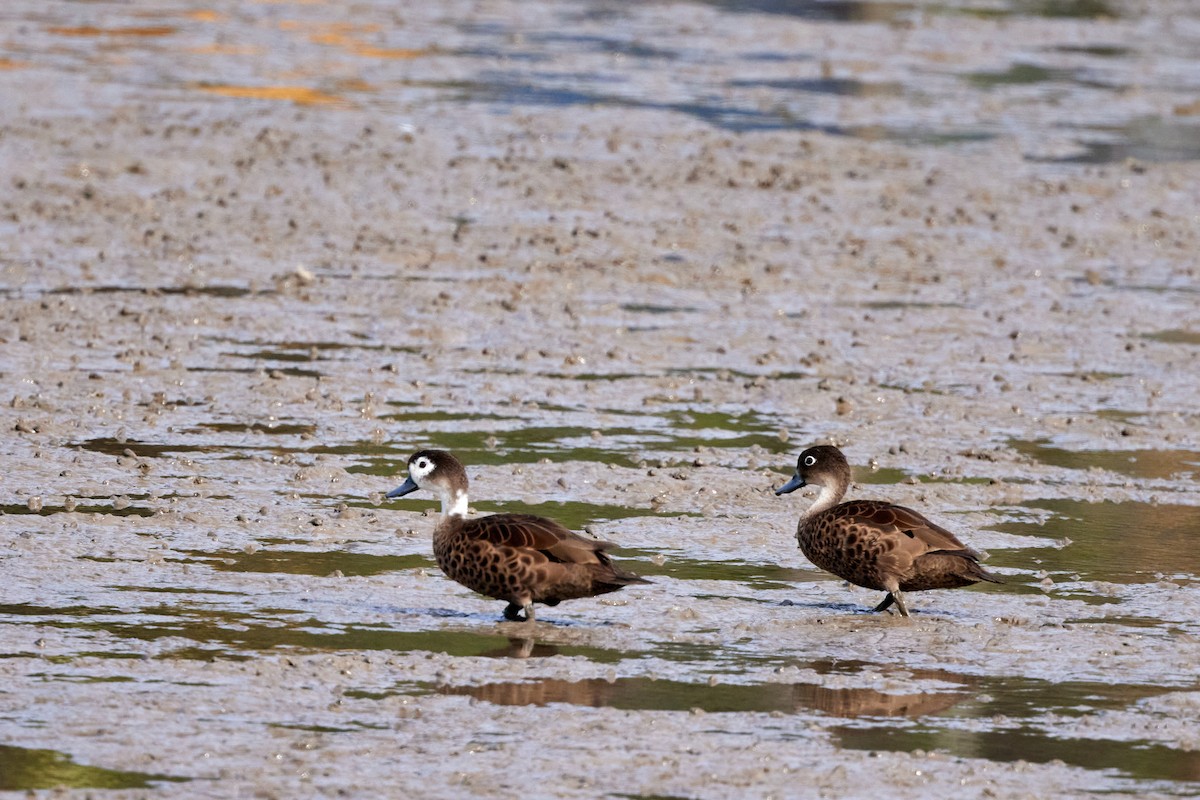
[775,445,1002,616]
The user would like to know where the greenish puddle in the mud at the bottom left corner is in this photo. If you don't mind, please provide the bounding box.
[0,745,192,792]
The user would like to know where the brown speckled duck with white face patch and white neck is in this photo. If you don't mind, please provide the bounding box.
[388,450,649,622]
